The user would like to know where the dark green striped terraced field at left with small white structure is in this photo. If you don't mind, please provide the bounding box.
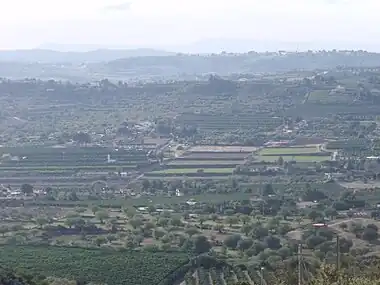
[0,147,150,185]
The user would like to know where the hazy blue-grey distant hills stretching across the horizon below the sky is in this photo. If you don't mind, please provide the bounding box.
[0,45,380,82]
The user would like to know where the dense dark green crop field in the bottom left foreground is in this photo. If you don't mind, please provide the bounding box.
[0,246,188,285]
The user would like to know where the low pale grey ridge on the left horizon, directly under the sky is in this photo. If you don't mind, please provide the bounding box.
[0,48,176,63]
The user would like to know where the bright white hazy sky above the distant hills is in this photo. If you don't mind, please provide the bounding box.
[0,0,380,49]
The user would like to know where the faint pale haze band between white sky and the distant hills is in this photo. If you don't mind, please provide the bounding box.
[0,38,380,64]
